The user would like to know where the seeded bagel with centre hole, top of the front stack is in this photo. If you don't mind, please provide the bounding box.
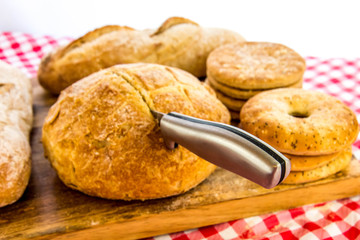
[240,88,359,155]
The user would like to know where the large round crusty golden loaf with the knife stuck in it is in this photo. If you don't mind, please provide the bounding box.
[42,63,230,200]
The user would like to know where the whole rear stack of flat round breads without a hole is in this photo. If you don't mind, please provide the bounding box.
[206,42,305,119]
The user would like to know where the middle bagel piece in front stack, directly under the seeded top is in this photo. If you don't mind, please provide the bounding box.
[284,147,351,172]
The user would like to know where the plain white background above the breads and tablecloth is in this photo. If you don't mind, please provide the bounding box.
[0,0,360,58]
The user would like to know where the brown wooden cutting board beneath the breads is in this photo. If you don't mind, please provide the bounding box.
[0,80,360,239]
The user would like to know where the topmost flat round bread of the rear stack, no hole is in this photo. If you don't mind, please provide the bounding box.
[207,42,305,89]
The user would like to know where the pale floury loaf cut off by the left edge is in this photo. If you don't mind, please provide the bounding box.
[0,61,33,207]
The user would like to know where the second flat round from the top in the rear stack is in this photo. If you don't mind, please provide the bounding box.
[206,76,303,99]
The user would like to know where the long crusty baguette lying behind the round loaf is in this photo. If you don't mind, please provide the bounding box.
[38,17,244,94]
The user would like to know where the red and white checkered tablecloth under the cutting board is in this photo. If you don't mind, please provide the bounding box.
[0,32,360,240]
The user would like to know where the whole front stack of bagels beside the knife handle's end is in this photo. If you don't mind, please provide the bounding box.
[240,88,359,184]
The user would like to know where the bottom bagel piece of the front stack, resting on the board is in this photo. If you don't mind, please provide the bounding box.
[283,146,352,184]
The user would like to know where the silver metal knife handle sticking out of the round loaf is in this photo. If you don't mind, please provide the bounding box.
[160,112,291,188]
